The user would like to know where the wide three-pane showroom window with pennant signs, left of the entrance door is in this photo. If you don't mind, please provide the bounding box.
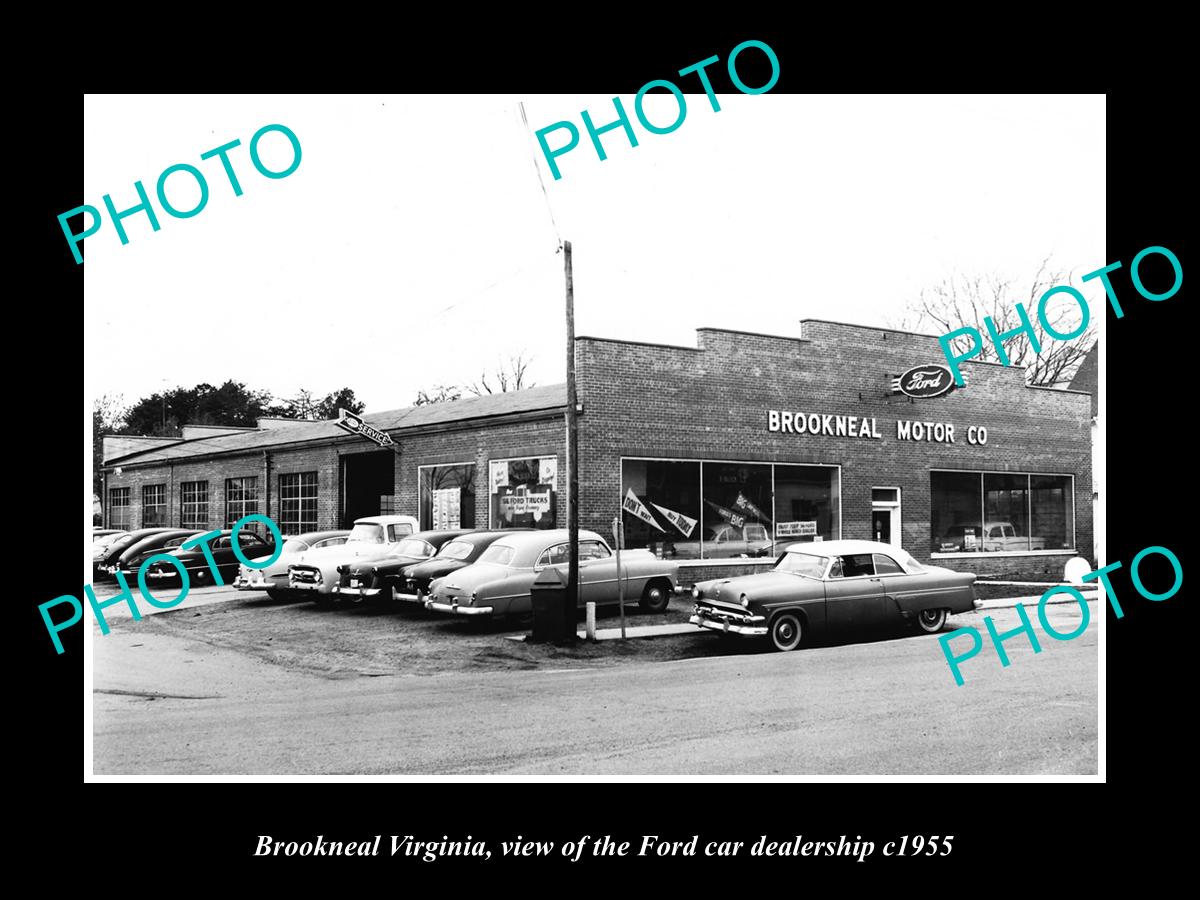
[620,460,841,559]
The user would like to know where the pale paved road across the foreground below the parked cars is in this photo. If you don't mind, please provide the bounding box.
[94,601,1098,780]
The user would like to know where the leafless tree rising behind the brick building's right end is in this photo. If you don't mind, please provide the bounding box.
[896,259,1096,385]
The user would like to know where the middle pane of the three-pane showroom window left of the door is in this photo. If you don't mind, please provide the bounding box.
[701,462,774,559]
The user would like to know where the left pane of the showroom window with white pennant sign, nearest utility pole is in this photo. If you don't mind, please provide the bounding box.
[620,460,700,559]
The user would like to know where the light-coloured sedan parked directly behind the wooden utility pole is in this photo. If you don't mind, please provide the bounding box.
[425,528,679,617]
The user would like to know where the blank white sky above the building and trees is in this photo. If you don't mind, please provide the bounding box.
[84,94,1110,412]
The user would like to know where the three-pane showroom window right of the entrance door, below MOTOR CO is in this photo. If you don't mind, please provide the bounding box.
[930,472,1075,553]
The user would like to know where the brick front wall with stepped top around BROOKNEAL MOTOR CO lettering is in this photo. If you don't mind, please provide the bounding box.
[576,322,1092,576]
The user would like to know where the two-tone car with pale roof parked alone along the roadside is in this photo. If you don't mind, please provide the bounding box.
[690,540,979,650]
